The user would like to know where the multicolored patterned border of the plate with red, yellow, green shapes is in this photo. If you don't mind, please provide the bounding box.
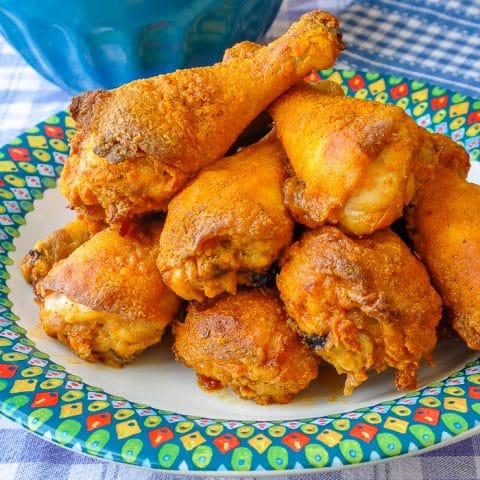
[0,70,480,475]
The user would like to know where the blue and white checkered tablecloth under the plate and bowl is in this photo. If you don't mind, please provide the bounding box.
[0,0,480,480]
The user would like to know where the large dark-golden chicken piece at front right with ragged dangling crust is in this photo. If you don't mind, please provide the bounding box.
[277,226,441,395]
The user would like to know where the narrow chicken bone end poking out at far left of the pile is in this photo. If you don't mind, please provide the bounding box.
[20,218,90,285]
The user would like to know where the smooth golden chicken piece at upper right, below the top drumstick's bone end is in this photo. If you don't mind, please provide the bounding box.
[269,84,421,235]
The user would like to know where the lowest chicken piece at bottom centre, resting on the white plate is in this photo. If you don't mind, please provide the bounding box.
[173,289,319,405]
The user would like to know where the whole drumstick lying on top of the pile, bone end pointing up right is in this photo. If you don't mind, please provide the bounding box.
[60,11,344,231]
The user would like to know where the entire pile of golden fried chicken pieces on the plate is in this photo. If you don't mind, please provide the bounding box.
[21,11,480,404]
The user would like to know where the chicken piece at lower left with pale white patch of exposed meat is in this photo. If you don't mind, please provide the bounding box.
[37,222,180,366]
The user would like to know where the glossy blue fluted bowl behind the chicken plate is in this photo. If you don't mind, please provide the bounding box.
[0,0,281,94]
